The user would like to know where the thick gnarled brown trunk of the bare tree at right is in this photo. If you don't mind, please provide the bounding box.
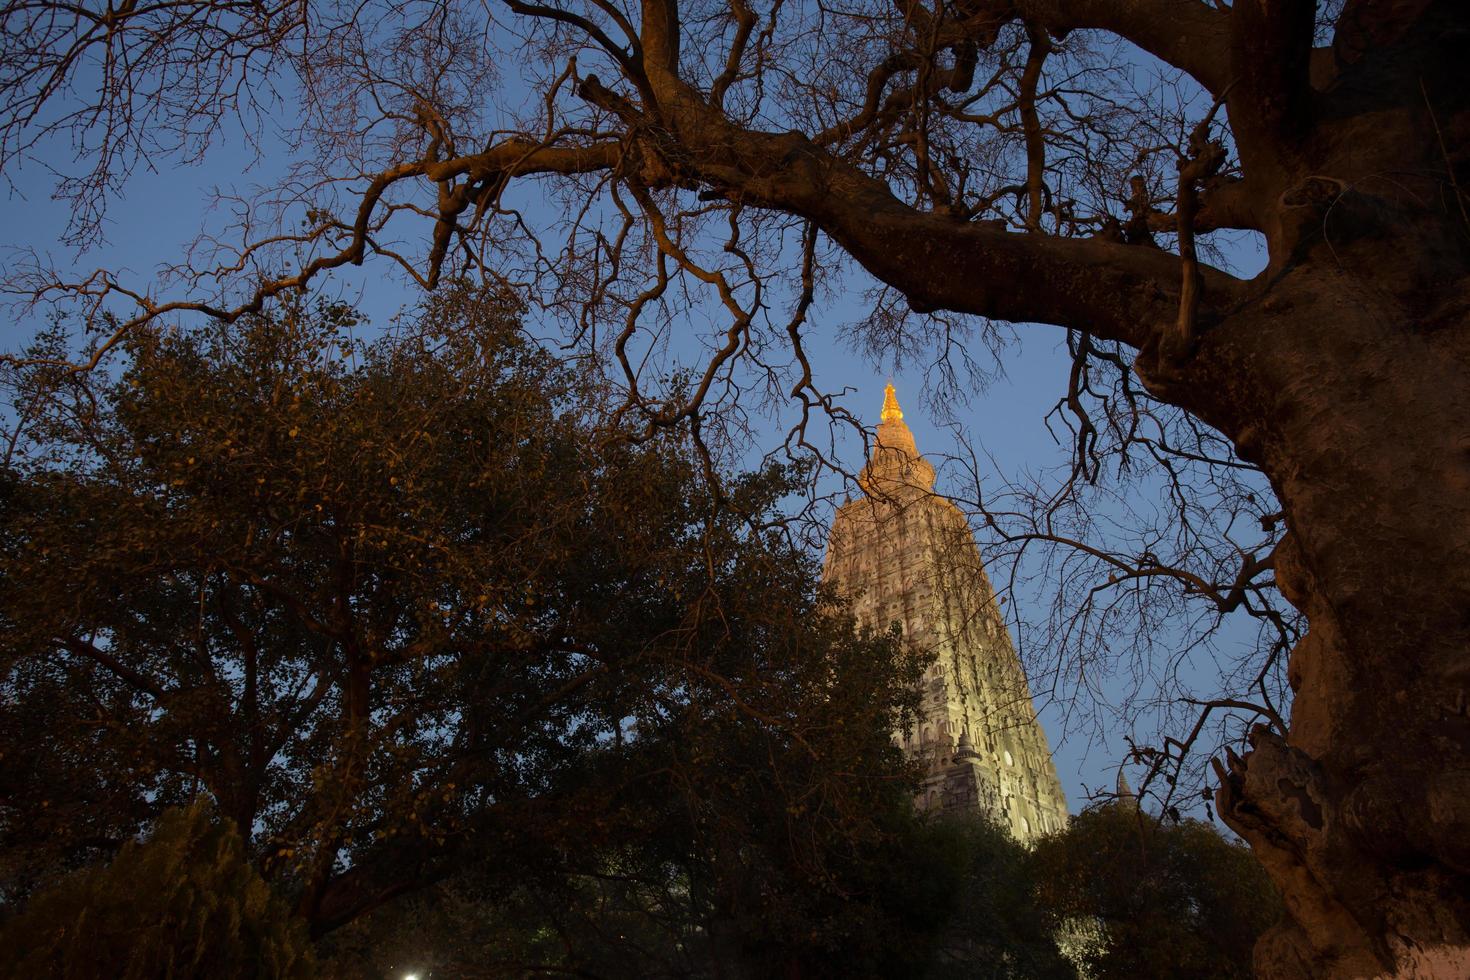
[1141,211,1470,977]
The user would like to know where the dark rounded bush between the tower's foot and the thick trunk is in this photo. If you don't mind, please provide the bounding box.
[1032,805,1282,980]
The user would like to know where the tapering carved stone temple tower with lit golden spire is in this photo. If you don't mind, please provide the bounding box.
[823,385,1067,840]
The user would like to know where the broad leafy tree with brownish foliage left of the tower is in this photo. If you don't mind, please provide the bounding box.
[0,289,920,952]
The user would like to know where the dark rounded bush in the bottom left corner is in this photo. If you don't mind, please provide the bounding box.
[0,802,316,980]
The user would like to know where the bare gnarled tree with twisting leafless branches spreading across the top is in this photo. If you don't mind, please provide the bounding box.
[0,0,1470,976]
